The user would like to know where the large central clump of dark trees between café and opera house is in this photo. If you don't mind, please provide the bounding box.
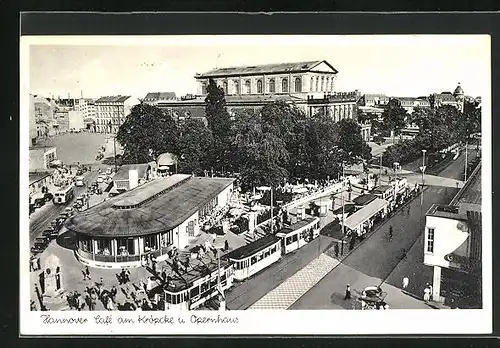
[117,81,371,188]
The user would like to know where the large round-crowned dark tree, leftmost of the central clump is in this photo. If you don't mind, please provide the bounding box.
[116,103,178,163]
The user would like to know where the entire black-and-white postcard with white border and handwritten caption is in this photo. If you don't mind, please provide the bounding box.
[20,35,492,334]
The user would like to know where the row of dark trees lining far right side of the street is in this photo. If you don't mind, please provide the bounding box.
[383,101,481,166]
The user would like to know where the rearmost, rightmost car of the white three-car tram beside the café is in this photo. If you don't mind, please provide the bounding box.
[276,217,319,254]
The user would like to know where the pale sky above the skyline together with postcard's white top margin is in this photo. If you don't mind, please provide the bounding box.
[25,35,491,98]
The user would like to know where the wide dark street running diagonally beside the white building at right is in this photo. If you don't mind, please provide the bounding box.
[290,150,474,309]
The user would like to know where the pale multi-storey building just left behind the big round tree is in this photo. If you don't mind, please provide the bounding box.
[95,95,140,133]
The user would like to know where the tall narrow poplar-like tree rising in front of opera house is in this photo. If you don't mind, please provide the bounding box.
[205,79,232,170]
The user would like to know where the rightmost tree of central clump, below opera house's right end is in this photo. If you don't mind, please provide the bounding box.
[337,119,371,164]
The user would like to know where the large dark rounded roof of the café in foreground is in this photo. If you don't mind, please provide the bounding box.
[66,174,234,238]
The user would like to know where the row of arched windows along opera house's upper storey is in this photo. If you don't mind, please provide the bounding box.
[202,76,334,94]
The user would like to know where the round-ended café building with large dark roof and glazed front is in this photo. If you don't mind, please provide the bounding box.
[66,174,234,268]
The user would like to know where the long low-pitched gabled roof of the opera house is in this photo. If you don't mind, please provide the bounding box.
[196,60,338,79]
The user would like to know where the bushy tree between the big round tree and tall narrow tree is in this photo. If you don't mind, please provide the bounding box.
[175,119,213,174]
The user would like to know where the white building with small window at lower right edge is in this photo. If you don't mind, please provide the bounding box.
[424,164,482,301]
